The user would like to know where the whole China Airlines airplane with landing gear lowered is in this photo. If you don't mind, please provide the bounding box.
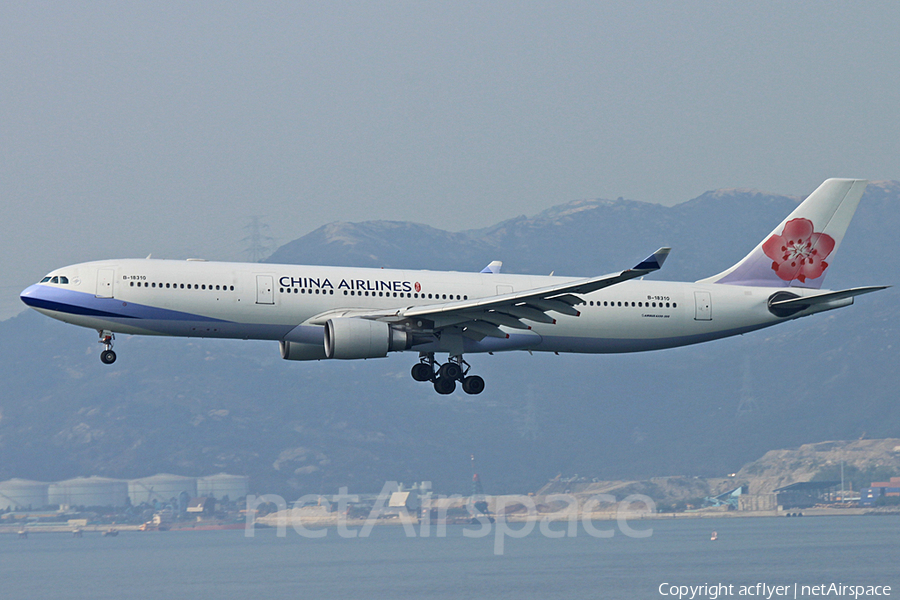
[20,179,888,394]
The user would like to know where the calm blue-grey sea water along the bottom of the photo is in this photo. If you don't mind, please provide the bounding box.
[0,515,900,600]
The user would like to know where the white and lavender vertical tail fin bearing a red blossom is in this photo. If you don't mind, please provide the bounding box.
[698,179,868,289]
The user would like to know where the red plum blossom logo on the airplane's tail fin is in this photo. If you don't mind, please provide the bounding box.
[762,219,834,283]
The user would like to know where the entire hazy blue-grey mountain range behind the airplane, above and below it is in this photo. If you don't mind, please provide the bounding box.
[0,182,900,496]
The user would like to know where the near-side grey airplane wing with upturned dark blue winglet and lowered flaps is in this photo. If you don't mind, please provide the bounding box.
[312,248,670,340]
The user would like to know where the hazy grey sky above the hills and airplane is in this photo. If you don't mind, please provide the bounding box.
[0,0,900,318]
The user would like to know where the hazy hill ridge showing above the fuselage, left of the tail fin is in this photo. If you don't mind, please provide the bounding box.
[265,190,800,280]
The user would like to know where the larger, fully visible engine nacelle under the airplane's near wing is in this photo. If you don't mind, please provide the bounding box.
[325,317,411,359]
